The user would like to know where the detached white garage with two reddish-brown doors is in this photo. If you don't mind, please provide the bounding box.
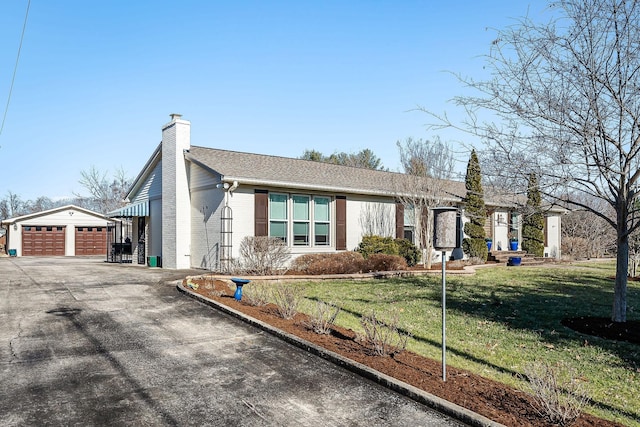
[2,205,108,256]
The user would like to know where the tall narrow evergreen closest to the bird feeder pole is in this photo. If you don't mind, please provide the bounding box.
[462,150,489,262]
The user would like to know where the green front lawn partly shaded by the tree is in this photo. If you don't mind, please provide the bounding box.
[292,262,640,426]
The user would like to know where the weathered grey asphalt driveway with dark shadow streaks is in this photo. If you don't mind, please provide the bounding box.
[0,257,459,427]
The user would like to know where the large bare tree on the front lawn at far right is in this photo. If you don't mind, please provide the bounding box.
[432,0,640,322]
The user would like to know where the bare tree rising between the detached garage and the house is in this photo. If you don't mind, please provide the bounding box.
[74,166,131,213]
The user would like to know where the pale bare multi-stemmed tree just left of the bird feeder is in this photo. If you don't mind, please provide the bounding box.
[396,137,454,268]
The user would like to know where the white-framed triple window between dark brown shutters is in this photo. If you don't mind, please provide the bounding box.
[269,193,331,247]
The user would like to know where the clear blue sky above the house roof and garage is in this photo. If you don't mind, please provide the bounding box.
[0,0,545,200]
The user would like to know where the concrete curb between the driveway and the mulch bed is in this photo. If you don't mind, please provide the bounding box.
[174,281,504,427]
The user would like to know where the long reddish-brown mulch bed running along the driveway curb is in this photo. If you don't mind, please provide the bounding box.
[184,280,624,427]
